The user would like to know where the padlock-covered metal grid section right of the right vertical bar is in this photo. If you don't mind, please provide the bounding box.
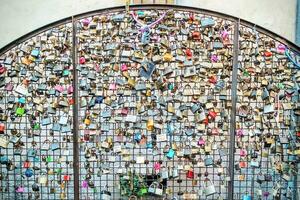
[234,23,299,199]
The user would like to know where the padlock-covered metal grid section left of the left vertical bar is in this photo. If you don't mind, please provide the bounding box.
[0,23,74,199]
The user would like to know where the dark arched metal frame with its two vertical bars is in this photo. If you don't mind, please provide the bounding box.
[0,4,300,200]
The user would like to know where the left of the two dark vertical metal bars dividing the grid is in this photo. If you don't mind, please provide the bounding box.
[72,17,79,200]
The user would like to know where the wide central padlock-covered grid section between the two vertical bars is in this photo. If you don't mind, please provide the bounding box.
[77,10,234,199]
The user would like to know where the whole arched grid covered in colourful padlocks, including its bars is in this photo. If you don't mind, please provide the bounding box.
[0,5,300,199]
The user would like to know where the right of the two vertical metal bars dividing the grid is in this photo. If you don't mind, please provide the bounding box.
[228,18,239,200]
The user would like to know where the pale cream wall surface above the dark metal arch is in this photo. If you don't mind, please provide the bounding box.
[0,0,296,48]
